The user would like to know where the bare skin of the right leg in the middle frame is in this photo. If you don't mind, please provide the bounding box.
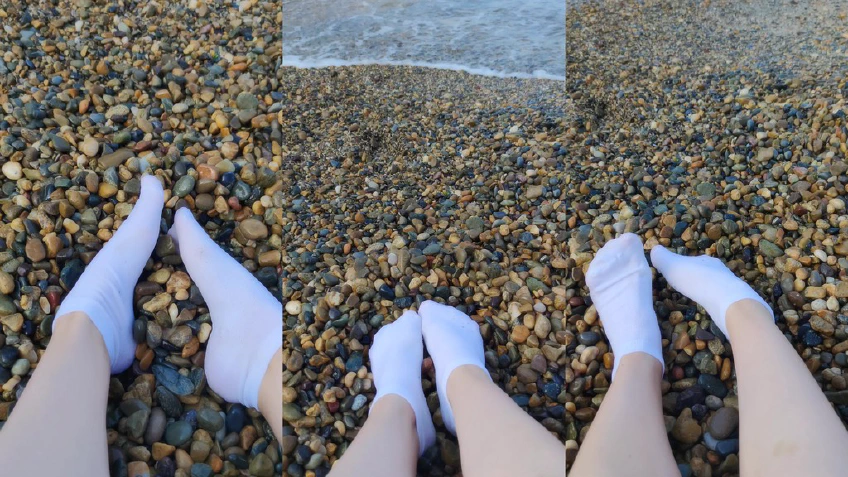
[448,365,565,477]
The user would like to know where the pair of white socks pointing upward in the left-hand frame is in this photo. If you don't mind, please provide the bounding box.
[53,176,283,407]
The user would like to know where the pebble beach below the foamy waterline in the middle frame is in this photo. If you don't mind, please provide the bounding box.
[282,66,572,477]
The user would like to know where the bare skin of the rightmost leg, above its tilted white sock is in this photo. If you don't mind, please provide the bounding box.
[727,300,848,477]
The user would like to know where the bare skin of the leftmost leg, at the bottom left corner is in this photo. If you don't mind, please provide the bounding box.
[0,312,109,477]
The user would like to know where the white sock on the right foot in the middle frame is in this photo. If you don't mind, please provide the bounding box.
[418,301,488,435]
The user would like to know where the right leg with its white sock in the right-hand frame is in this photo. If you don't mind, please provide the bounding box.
[651,247,848,477]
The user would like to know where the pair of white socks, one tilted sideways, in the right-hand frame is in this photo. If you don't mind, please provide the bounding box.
[586,233,771,377]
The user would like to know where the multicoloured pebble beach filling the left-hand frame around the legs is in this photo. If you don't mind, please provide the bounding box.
[0,0,285,477]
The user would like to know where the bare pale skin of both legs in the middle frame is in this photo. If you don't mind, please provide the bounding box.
[331,365,565,477]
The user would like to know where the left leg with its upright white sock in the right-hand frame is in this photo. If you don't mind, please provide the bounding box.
[571,234,680,477]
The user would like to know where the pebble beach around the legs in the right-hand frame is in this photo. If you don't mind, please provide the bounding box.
[560,0,848,477]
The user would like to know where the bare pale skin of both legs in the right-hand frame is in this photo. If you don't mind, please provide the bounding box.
[569,299,848,477]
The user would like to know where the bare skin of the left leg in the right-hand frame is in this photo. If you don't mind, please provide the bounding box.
[571,353,680,477]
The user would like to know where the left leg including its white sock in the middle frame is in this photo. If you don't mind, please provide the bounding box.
[330,311,436,477]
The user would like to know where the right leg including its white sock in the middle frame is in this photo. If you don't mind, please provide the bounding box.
[419,301,565,477]
